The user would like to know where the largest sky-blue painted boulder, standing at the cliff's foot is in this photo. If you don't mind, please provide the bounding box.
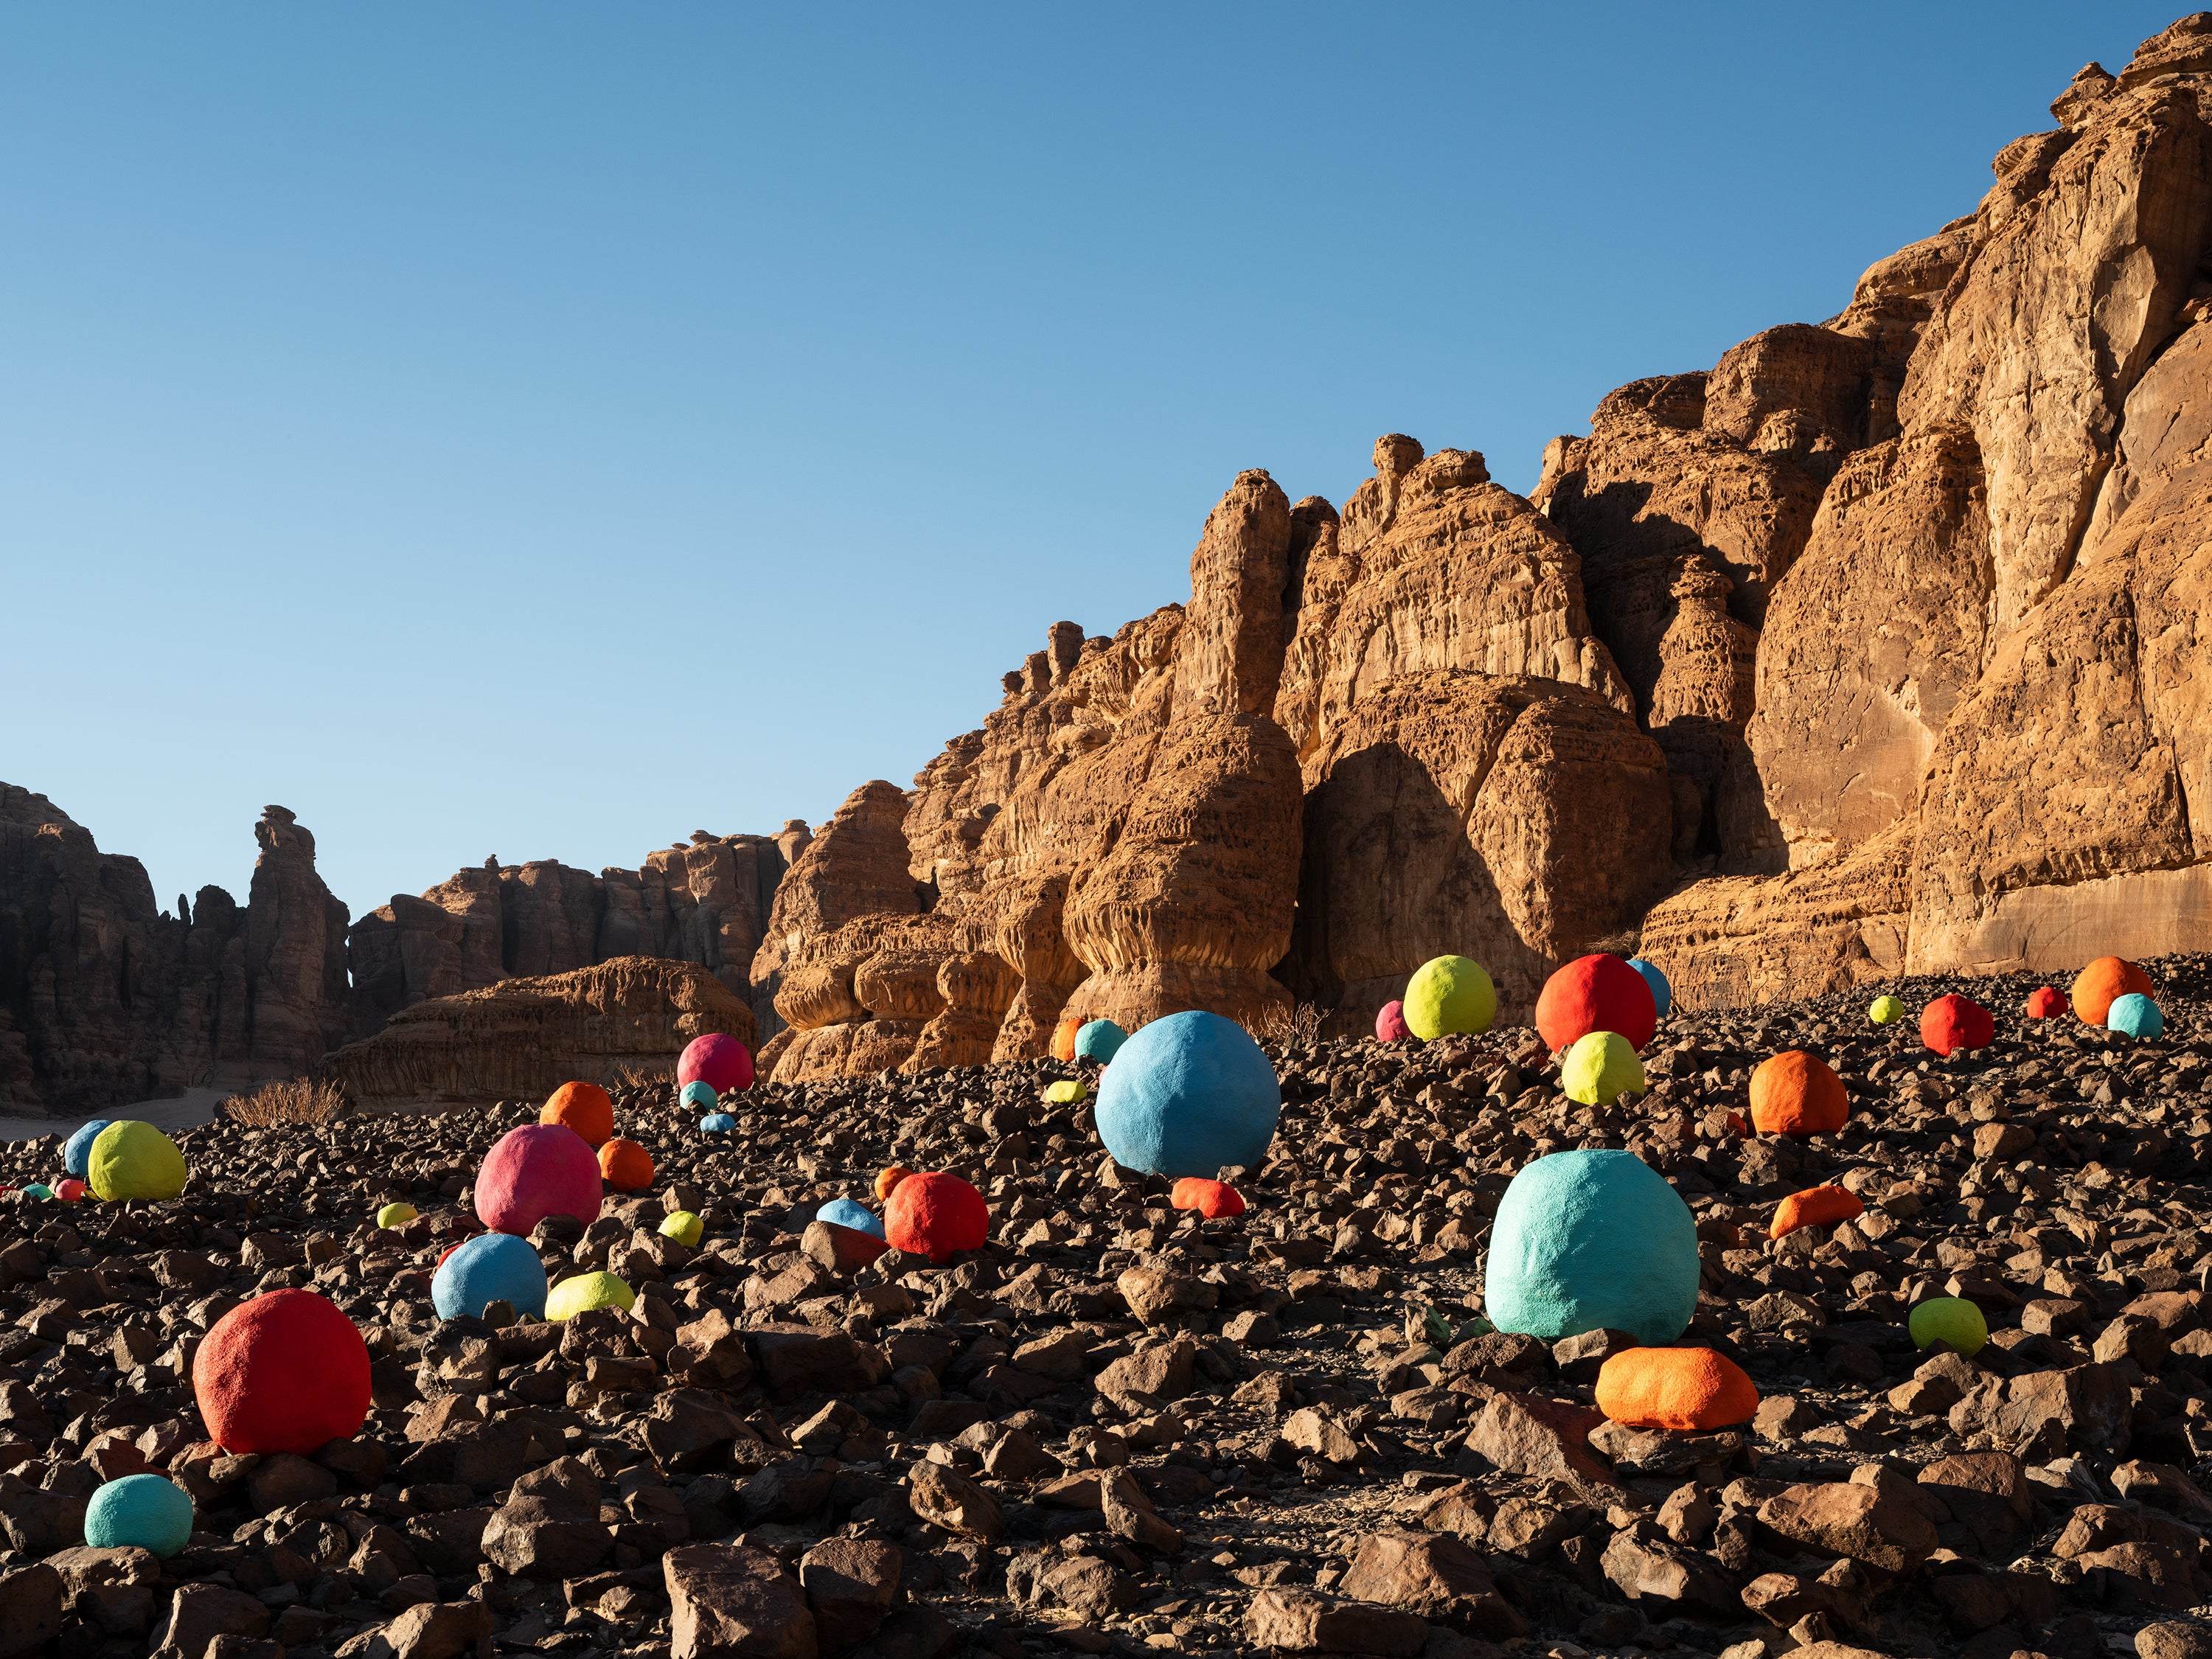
[1097,1009,1283,1179]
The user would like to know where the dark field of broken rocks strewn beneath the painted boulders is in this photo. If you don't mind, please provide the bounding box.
[0,958,2212,1659]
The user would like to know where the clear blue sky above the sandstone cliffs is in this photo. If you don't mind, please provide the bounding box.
[0,0,2179,914]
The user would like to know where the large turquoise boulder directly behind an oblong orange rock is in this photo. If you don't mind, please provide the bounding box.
[1482,1152,1697,1347]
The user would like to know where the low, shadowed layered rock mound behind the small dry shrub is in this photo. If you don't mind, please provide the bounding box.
[319,956,754,1110]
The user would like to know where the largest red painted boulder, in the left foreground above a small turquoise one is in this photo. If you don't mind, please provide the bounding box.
[192,1290,369,1458]
